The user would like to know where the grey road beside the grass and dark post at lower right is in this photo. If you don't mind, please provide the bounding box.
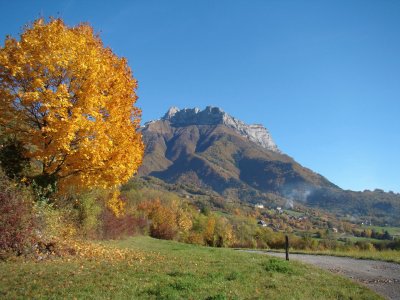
[248,251,400,299]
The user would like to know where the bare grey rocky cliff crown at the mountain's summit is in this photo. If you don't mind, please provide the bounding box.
[162,106,280,153]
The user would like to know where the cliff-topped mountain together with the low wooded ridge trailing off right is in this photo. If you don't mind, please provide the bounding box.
[139,107,400,223]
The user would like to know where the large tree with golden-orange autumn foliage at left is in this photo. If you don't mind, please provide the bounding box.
[0,19,144,188]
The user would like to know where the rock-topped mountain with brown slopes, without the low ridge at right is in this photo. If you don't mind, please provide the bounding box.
[140,107,335,195]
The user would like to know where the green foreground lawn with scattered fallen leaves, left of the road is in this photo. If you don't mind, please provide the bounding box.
[0,237,381,299]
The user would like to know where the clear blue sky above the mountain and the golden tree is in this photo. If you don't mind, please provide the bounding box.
[0,0,400,192]
